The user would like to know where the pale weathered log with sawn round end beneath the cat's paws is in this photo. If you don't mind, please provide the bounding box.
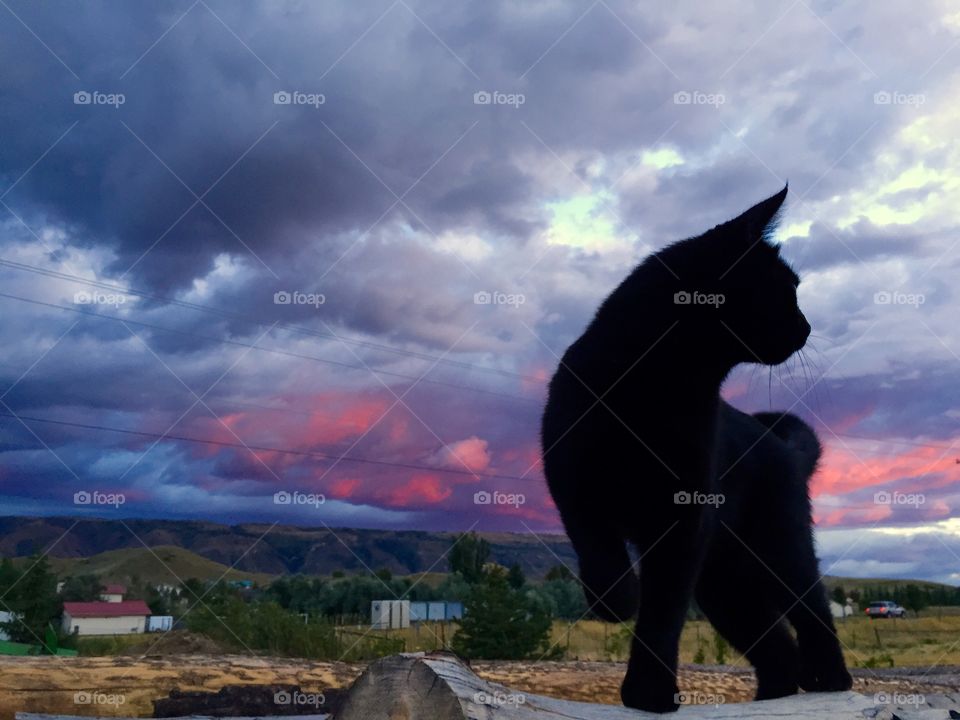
[336,653,960,720]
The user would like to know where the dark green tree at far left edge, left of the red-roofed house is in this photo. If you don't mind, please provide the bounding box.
[0,555,63,644]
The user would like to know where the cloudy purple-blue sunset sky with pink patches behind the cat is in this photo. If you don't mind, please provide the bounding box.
[0,0,960,583]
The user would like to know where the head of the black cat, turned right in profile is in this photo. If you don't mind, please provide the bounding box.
[661,187,810,365]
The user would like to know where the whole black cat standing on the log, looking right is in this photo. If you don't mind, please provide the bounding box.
[542,187,851,712]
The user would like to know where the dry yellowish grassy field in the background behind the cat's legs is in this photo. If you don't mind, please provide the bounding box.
[366,608,960,667]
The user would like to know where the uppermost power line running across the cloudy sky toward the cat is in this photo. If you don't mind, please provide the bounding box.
[0,258,544,383]
